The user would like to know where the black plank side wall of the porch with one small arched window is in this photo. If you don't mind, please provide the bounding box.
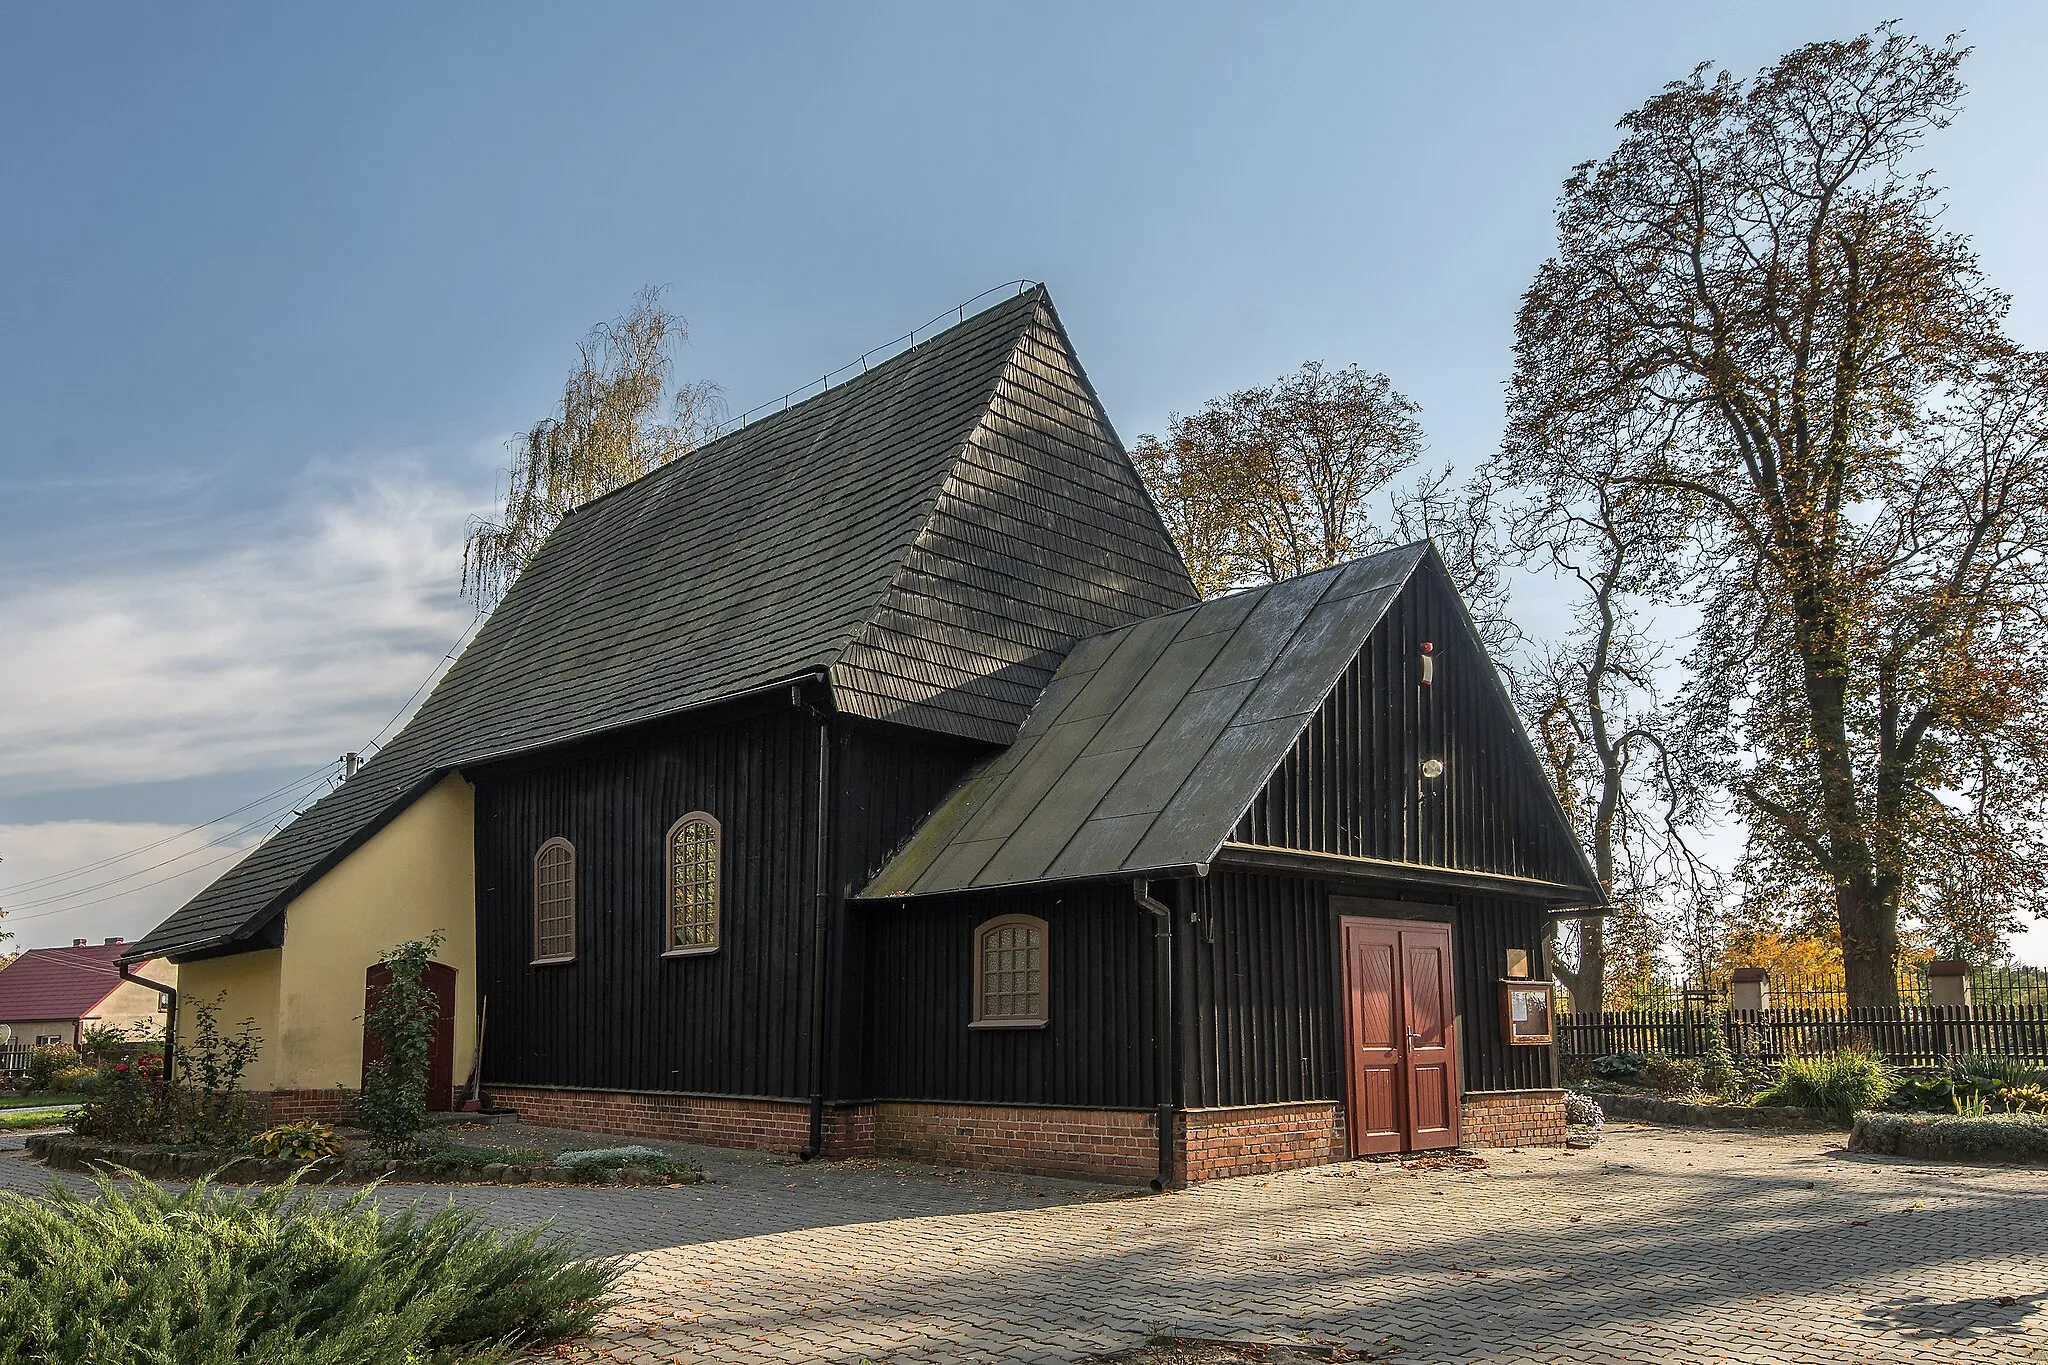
[854,884,1157,1109]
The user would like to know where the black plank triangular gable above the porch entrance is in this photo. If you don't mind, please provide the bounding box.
[1231,571,1583,884]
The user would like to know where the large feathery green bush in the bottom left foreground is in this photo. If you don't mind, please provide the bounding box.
[0,1179,623,1365]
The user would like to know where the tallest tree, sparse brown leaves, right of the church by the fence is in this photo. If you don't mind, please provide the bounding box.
[1507,27,2048,1005]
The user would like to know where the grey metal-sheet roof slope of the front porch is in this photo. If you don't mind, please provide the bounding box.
[862,544,1427,896]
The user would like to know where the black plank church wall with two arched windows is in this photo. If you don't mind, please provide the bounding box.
[473,708,817,1097]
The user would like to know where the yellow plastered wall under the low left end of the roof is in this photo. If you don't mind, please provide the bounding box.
[180,776,477,1091]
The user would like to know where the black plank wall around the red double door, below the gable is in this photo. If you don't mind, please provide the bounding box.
[1178,872,1550,1107]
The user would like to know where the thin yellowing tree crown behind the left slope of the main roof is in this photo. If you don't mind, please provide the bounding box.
[463,287,723,606]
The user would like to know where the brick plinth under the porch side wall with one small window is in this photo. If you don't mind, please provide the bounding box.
[874,1101,1159,1185]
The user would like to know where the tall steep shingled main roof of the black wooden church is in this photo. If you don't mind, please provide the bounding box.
[131,289,1194,958]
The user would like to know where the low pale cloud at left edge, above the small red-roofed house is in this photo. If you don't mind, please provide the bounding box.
[0,812,270,950]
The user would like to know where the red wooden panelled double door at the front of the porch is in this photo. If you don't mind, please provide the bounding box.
[1341,917,1458,1156]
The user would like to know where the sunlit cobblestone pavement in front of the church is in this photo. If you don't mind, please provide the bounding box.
[0,1124,2048,1365]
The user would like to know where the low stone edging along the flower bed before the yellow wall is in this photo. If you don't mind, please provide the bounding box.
[23,1134,705,1185]
